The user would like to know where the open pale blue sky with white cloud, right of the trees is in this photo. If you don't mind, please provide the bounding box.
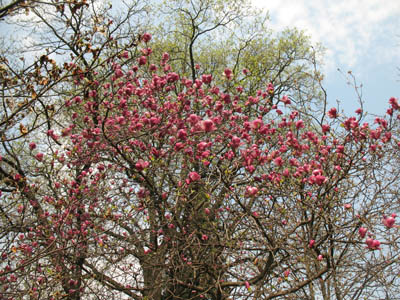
[252,0,400,114]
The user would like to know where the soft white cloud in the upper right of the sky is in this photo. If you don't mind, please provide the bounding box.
[253,0,400,73]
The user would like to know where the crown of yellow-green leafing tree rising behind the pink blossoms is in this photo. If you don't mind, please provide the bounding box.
[152,0,326,115]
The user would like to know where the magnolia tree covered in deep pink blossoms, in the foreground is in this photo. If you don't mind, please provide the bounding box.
[0,28,400,300]
